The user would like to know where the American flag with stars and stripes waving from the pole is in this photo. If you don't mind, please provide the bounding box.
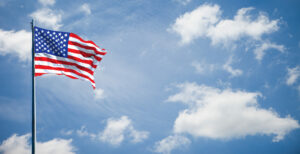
[34,27,106,89]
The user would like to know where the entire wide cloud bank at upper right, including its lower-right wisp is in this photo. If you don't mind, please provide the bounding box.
[169,4,284,60]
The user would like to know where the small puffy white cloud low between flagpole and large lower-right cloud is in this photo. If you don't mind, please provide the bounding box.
[99,116,149,146]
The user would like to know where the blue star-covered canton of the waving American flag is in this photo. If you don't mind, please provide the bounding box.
[34,27,70,57]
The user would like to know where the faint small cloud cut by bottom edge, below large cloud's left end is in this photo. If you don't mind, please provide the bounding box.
[154,135,191,154]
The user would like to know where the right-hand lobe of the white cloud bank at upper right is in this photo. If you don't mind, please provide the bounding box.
[207,8,279,44]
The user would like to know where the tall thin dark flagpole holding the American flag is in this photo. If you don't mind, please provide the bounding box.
[31,19,36,154]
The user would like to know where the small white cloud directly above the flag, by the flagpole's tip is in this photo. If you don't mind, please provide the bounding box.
[30,8,62,30]
